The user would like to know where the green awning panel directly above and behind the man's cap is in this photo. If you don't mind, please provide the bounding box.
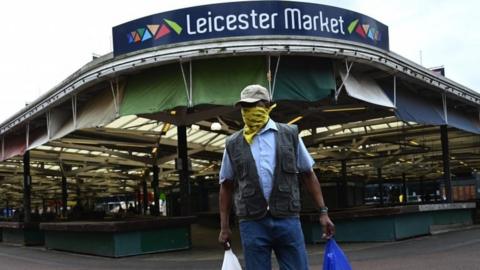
[192,56,268,105]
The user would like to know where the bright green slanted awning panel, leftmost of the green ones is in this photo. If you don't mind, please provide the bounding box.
[120,63,188,115]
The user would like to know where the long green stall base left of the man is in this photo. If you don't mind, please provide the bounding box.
[43,217,195,257]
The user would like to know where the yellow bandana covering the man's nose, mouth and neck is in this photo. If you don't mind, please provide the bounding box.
[242,104,277,144]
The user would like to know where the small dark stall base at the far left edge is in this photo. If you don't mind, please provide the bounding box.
[0,222,45,246]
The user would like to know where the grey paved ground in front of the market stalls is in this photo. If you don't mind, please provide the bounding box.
[0,226,480,270]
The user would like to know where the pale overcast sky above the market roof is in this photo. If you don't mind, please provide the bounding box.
[0,0,480,122]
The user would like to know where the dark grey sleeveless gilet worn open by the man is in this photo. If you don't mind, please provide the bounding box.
[226,123,300,220]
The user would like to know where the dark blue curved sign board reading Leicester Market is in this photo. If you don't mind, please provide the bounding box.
[113,1,389,56]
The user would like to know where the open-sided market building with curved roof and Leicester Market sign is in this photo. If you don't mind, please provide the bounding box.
[0,1,480,257]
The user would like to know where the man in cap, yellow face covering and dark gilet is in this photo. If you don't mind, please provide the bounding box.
[218,85,334,270]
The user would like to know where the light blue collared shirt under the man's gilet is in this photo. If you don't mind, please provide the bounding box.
[220,119,315,201]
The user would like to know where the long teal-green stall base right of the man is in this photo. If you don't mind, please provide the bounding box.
[302,203,475,243]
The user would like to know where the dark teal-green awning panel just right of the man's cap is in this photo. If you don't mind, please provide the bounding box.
[273,56,335,101]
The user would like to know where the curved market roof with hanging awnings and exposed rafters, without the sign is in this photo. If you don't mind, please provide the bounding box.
[0,2,480,206]
